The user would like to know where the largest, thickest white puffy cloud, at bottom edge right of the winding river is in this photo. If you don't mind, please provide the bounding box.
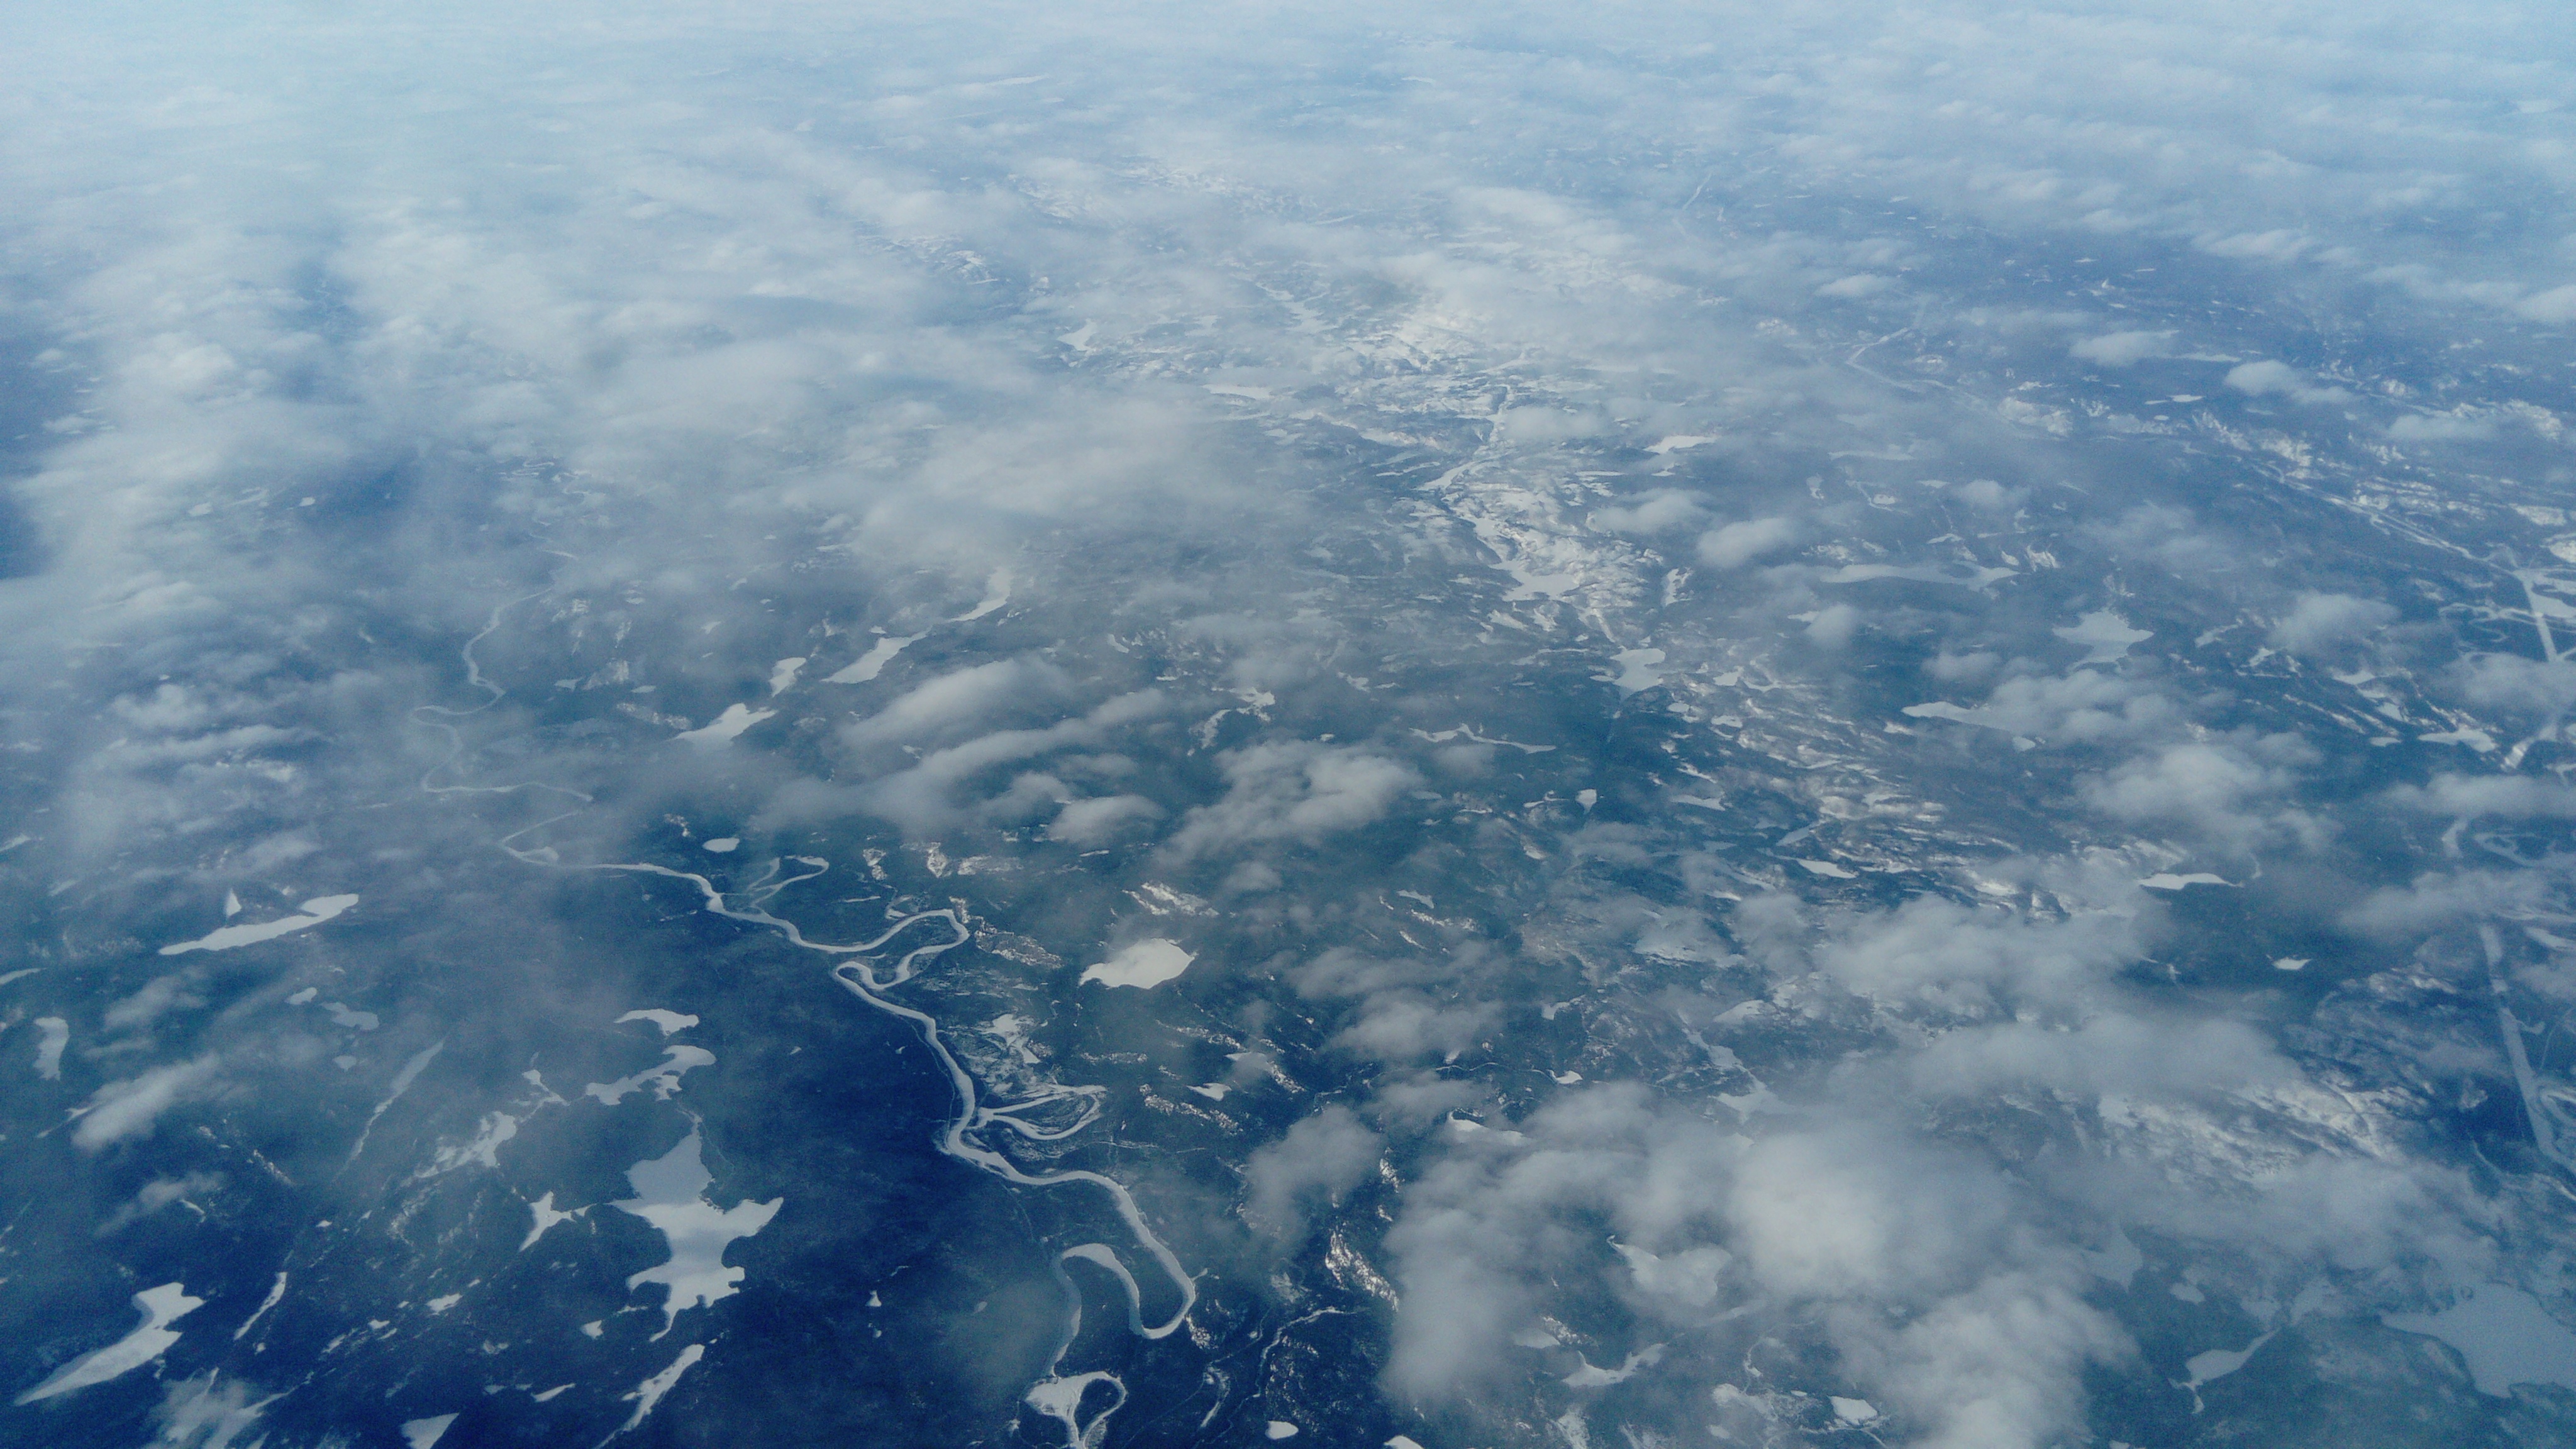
[1386,1088,2133,1446]
